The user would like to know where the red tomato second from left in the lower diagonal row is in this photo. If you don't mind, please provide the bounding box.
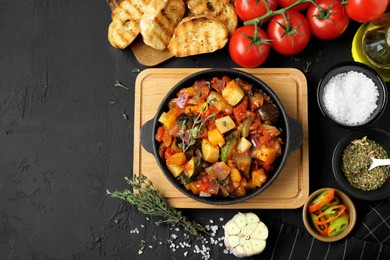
[267,10,310,55]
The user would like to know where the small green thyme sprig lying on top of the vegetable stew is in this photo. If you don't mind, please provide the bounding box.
[178,106,216,153]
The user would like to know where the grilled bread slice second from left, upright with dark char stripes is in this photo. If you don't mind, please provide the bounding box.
[140,0,186,50]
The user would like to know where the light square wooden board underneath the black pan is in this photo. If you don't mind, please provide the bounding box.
[133,68,309,209]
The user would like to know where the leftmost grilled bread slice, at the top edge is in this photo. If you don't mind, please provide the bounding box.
[108,0,150,49]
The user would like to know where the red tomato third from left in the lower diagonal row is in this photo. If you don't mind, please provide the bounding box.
[306,0,349,40]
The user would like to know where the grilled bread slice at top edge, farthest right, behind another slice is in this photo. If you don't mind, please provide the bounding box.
[187,0,238,35]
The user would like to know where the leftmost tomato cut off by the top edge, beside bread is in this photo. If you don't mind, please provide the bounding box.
[234,0,278,21]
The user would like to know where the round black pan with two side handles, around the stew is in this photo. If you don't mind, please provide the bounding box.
[141,69,303,205]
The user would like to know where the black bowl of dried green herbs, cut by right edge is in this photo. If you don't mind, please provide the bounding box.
[332,128,390,201]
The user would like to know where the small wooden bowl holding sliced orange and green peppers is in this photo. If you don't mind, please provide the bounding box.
[302,188,356,242]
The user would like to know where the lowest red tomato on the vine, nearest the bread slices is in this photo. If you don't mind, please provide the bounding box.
[229,25,271,68]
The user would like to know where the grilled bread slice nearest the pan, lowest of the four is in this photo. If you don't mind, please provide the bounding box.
[168,16,228,57]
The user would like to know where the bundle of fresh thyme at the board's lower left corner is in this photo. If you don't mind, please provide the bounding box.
[106,174,208,239]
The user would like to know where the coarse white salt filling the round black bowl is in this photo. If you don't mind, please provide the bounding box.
[323,71,379,125]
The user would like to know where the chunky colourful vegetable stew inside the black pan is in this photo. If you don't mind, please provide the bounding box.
[155,76,283,197]
